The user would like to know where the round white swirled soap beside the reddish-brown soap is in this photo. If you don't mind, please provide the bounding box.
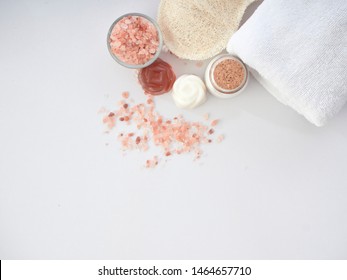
[172,75,207,109]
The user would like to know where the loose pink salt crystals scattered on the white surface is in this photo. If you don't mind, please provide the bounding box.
[103,92,223,168]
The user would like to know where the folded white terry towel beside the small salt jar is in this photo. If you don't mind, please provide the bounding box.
[227,0,347,126]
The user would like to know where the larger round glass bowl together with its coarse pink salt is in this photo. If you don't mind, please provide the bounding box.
[107,13,163,69]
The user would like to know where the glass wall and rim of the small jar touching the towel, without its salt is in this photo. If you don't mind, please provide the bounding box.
[205,54,249,98]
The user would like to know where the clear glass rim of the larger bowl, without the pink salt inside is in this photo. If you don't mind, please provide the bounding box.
[107,13,163,69]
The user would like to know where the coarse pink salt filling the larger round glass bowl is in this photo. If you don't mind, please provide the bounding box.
[109,16,159,65]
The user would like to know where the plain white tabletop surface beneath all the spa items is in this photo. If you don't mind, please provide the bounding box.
[0,0,347,259]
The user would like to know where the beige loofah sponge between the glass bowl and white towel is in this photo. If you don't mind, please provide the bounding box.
[158,0,256,60]
